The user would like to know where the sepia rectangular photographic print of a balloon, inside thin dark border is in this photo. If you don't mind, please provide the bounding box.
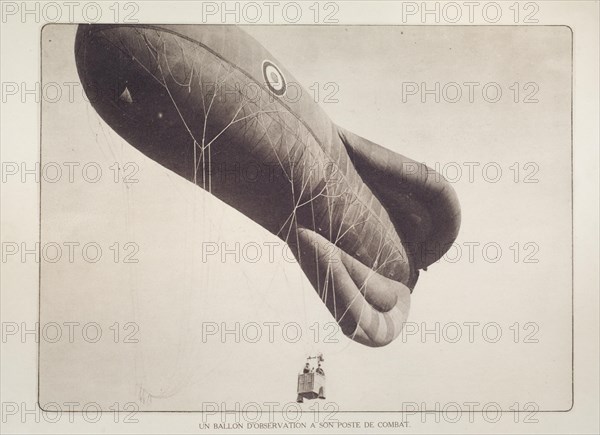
[40,25,572,411]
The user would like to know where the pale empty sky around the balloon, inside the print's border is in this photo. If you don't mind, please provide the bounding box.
[40,26,571,410]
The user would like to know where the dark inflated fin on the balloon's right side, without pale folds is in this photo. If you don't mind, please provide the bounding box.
[339,128,460,269]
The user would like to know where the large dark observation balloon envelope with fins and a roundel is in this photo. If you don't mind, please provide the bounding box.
[75,25,460,346]
